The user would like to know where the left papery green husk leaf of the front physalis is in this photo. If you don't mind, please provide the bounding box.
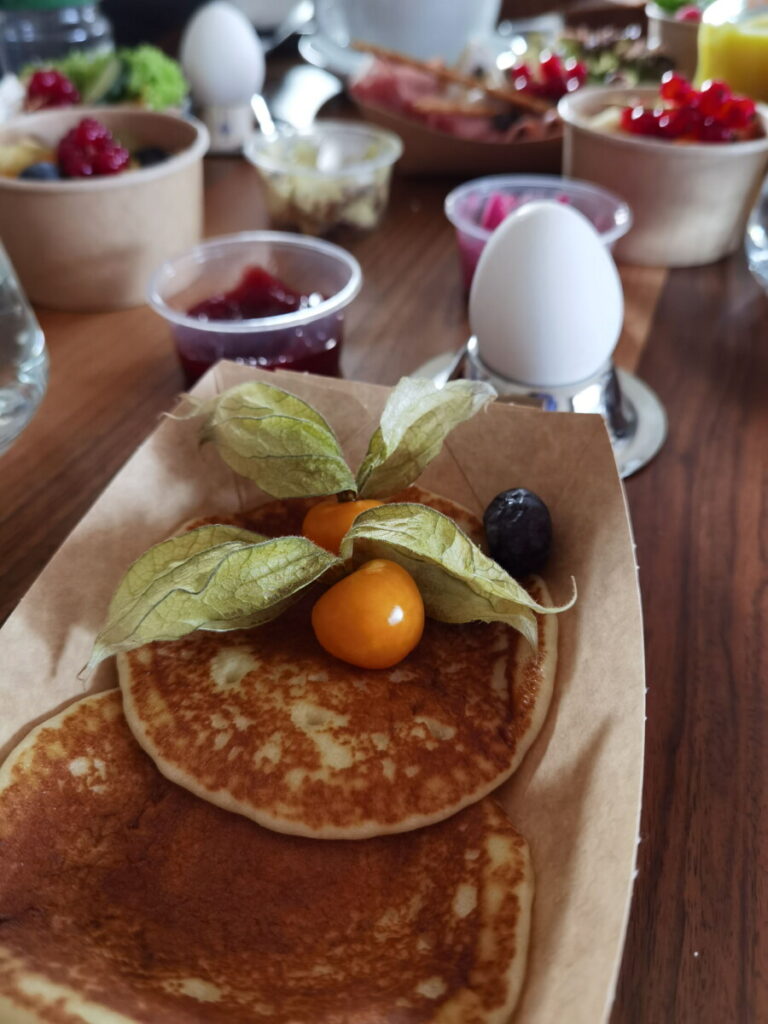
[86,526,341,672]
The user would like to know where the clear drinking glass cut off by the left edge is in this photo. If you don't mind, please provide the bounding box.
[0,245,48,455]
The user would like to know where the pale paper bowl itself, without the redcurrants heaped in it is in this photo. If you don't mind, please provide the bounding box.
[558,87,768,266]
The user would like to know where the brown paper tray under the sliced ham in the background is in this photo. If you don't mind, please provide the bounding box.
[352,96,562,175]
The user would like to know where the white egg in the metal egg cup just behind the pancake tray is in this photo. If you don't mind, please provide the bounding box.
[469,201,624,387]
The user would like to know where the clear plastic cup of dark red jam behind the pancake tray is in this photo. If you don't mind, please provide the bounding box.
[147,231,362,385]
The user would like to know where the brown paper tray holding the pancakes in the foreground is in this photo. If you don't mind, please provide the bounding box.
[0,362,645,1024]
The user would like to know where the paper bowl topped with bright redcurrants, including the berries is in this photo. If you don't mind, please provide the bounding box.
[558,73,768,266]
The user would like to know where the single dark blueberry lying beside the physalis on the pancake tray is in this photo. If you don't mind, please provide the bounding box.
[482,487,552,580]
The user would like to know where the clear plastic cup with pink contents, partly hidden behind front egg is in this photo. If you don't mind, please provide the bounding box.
[444,174,632,293]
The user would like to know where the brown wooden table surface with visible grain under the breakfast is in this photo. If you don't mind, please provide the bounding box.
[0,148,768,1024]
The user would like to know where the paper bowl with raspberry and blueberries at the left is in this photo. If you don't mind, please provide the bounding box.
[0,106,208,311]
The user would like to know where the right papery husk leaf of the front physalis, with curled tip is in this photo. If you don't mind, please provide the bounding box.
[341,502,575,647]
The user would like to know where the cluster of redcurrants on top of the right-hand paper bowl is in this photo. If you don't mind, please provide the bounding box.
[618,71,763,142]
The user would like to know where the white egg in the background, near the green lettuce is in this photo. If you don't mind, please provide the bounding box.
[179,0,264,106]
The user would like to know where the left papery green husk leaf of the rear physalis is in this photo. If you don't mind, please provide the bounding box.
[200,381,356,498]
